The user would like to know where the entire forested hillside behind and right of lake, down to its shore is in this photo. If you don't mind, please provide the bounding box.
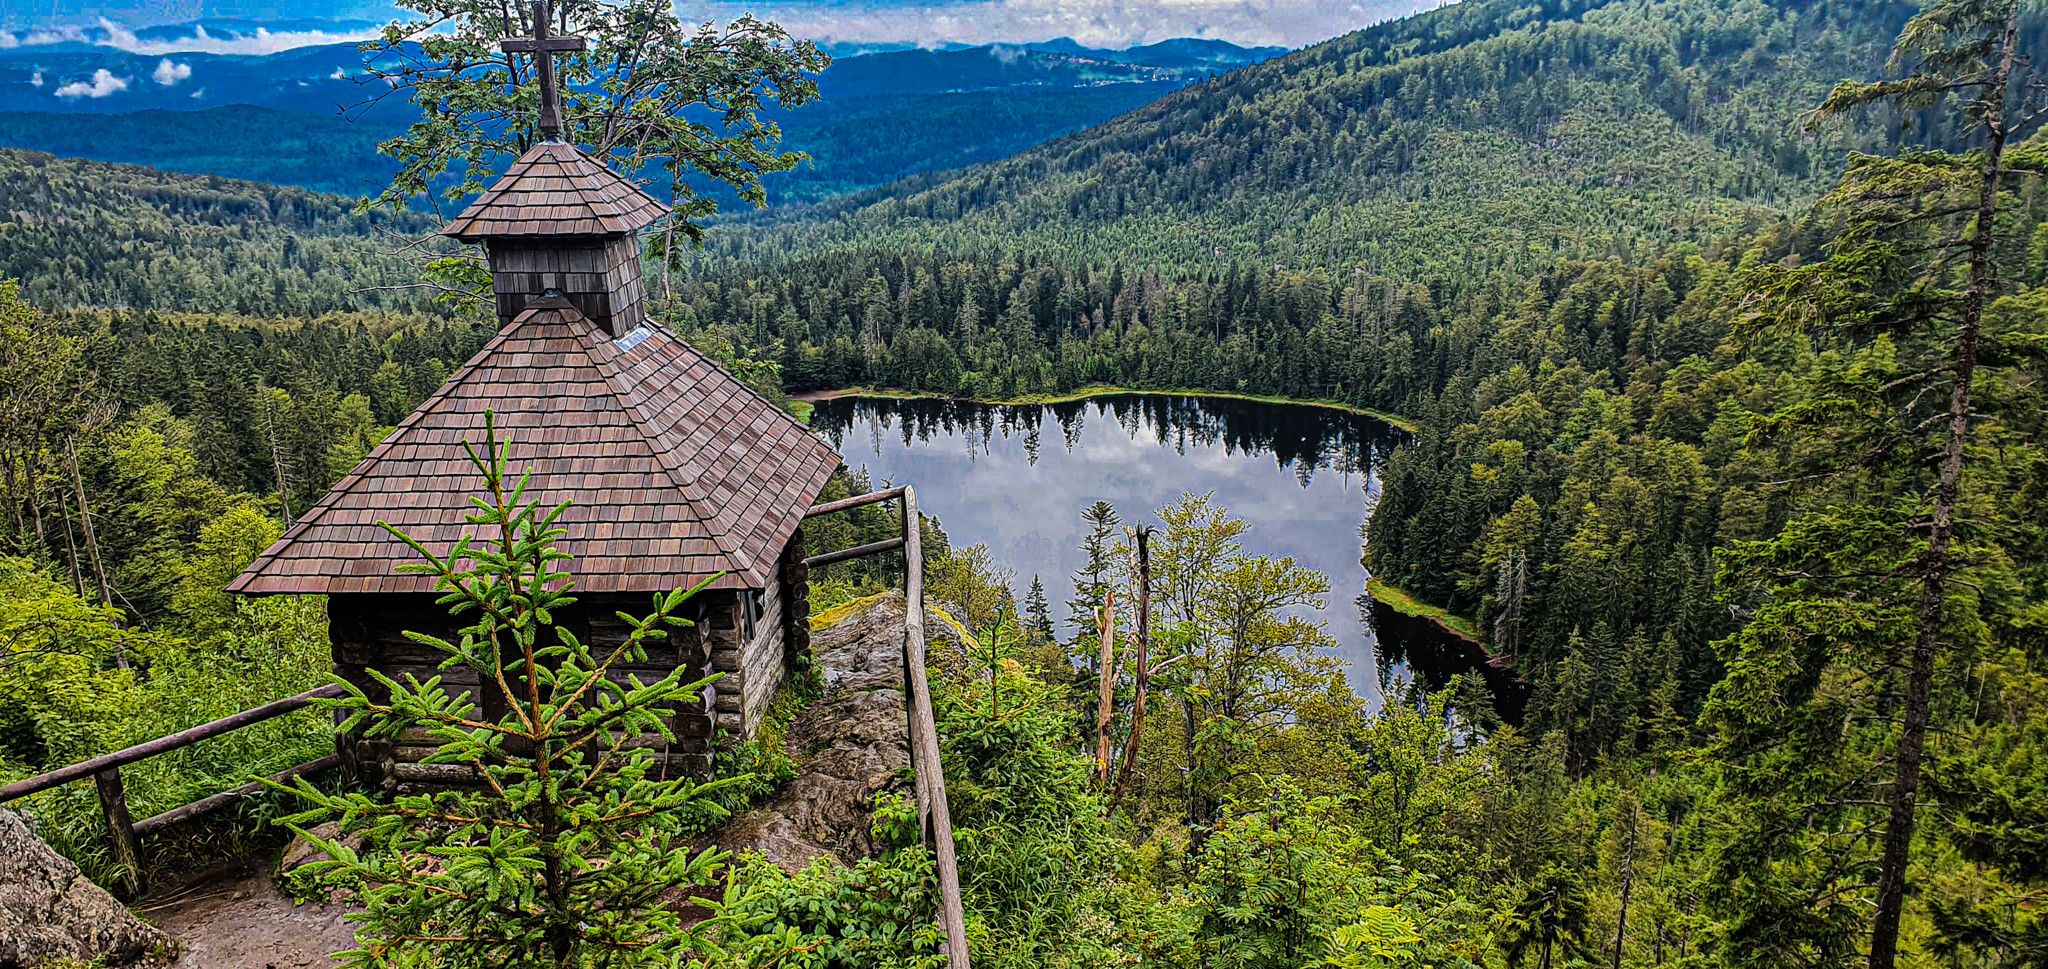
[676,0,2048,733]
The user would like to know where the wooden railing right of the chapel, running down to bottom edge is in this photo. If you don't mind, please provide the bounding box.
[803,486,967,969]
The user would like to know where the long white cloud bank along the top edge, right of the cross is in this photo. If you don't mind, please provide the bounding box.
[676,0,1444,47]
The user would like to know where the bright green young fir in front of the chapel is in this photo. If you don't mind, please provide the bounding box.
[287,414,743,969]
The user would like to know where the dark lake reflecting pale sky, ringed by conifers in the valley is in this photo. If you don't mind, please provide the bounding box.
[811,395,1515,699]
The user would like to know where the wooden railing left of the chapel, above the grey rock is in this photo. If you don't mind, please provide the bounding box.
[0,686,348,895]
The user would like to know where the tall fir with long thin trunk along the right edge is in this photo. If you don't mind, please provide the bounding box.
[1708,0,2048,969]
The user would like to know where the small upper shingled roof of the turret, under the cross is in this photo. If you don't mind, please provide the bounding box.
[440,141,668,242]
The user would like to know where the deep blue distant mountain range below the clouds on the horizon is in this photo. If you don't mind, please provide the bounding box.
[0,20,1286,203]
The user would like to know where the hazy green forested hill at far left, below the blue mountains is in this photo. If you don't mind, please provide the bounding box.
[0,150,446,315]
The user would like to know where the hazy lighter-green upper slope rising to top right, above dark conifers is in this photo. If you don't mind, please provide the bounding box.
[717,0,1949,281]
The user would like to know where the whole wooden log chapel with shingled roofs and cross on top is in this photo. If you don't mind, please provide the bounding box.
[229,33,840,789]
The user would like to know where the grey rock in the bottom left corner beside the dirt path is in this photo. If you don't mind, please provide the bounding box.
[0,811,174,969]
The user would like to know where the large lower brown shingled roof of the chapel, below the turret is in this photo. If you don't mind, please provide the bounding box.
[227,297,840,596]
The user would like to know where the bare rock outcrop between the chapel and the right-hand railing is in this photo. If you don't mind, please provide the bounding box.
[709,592,958,871]
